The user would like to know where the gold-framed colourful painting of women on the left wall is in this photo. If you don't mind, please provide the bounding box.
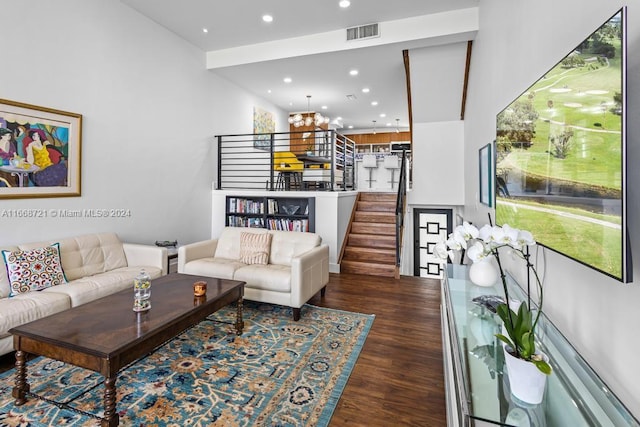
[0,99,82,199]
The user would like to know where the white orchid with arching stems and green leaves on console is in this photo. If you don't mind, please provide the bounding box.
[434,221,551,375]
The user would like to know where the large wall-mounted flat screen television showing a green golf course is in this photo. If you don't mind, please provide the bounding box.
[495,8,633,283]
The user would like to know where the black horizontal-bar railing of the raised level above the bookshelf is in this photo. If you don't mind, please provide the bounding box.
[215,130,355,191]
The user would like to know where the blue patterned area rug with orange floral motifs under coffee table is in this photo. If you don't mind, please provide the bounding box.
[0,301,373,427]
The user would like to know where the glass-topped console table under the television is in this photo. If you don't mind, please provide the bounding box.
[441,264,640,427]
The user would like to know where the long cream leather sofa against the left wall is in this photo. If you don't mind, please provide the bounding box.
[0,233,167,355]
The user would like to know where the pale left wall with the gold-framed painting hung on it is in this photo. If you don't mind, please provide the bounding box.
[0,0,286,245]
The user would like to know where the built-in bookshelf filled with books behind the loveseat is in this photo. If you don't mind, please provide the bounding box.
[226,196,315,232]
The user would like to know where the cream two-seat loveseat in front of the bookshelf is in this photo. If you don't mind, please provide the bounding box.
[178,227,329,320]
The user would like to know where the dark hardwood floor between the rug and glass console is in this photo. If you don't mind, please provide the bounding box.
[0,274,447,427]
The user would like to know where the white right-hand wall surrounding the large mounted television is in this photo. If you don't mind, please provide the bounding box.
[465,0,640,418]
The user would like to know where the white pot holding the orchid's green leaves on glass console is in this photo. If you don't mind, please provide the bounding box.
[503,346,548,405]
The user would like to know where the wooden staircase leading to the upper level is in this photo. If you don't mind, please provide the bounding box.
[340,192,399,278]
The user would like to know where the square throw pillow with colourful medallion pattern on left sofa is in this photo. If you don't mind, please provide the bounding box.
[2,243,67,297]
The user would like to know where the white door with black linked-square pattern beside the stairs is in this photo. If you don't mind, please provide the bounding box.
[413,209,453,279]
